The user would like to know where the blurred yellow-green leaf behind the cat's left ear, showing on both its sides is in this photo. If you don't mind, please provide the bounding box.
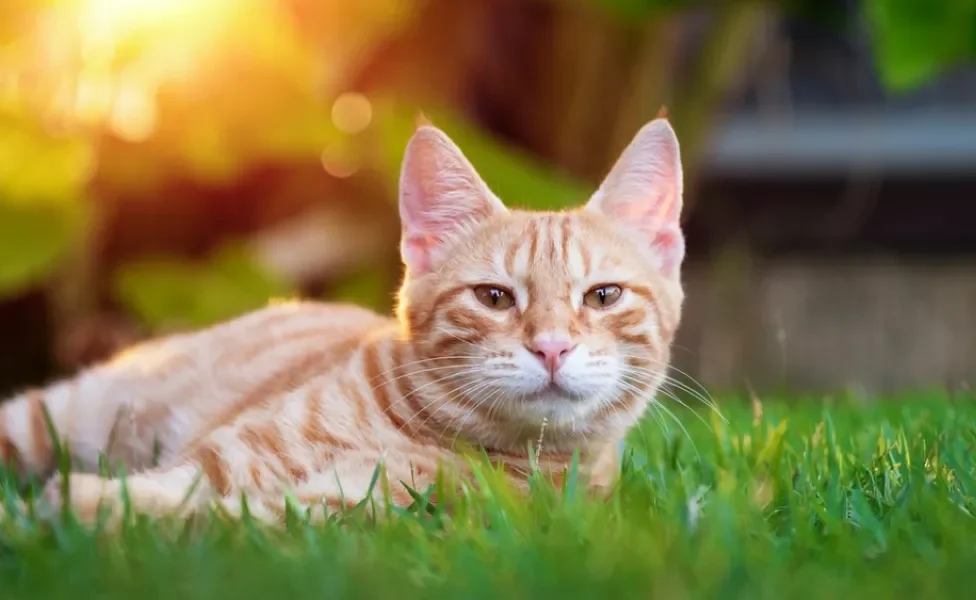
[373,101,592,210]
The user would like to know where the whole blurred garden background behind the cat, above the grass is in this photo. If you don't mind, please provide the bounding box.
[0,0,976,393]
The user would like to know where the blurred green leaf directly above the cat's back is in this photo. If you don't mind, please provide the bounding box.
[113,246,292,330]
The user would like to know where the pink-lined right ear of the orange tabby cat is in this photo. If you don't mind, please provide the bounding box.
[586,118,685,277]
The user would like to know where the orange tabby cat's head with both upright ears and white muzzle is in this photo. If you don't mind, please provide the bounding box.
[399,119,684,454]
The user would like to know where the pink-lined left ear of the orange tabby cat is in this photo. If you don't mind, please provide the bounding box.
[400,124,507,275]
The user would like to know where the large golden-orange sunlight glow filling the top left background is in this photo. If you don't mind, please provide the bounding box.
[8,0,392,186]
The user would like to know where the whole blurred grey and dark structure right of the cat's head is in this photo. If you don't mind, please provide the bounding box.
[675,3,976,392]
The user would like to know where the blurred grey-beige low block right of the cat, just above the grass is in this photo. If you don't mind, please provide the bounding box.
[674,259,976,393]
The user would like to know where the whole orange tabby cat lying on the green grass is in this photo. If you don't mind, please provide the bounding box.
[0,113,685,522]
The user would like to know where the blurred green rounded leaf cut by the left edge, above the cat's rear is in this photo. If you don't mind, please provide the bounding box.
[0,202,86,298]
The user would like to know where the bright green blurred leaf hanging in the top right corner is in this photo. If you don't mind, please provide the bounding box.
[865,0,976,91]
